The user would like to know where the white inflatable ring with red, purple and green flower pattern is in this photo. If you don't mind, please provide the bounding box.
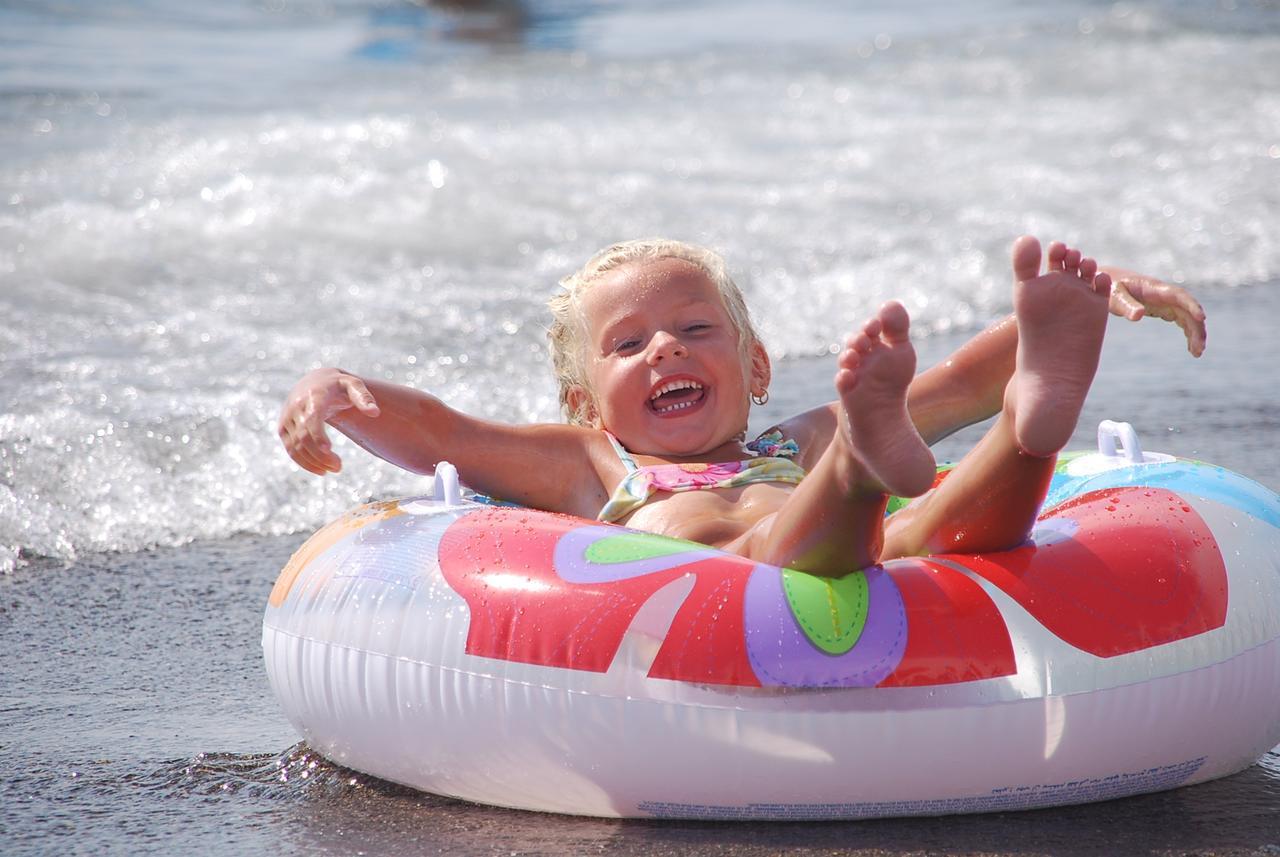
[262,427,1280,819]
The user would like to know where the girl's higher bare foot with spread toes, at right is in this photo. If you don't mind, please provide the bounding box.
[1005,235,1111,458]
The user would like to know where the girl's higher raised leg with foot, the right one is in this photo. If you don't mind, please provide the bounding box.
[883,238,1110,558]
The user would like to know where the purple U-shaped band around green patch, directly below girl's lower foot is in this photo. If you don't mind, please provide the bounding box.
[744,564,906,687]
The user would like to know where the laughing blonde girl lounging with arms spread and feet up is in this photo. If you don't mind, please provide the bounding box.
[279,237,1204,576]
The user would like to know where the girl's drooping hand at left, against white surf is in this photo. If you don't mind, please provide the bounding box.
[278,368,381,476]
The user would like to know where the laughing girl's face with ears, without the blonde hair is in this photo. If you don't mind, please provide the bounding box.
[570,258,769,457]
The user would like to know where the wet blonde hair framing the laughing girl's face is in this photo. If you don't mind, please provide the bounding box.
[547,238,760,426]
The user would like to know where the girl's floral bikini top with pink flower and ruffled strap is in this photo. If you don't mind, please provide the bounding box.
[596,430,804,521]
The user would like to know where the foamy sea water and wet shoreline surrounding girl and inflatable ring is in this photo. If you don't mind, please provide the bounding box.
[0,0,1280,853]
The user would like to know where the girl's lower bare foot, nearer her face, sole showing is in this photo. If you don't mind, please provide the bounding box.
[836,301,934,496]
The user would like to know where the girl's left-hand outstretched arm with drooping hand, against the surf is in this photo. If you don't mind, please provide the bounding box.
[279,368,604,517]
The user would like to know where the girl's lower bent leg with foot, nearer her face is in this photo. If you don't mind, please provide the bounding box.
[728,303,933,576]
